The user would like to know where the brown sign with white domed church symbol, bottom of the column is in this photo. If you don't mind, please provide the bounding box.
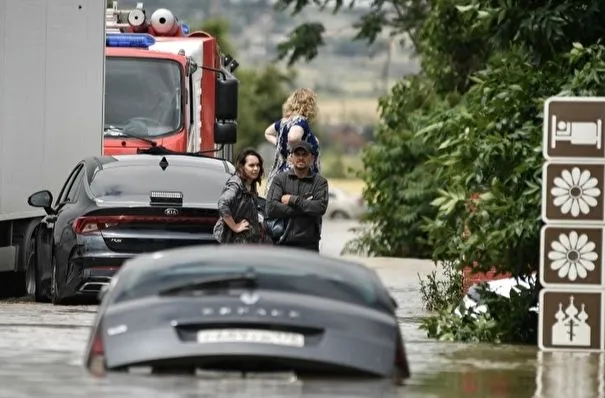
[538,288,605,352]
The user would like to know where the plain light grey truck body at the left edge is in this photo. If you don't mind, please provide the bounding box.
[0,0,107,279]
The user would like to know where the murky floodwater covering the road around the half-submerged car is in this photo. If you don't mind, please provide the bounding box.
[0,222,605,398]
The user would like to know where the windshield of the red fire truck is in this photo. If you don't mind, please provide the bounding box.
[105,57,183,137]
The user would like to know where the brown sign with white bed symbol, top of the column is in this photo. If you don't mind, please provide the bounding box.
[542,97,605,160]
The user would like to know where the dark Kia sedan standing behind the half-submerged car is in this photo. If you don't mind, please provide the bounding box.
[27,154,233,303]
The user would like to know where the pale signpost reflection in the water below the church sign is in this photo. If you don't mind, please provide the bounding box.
[534,351,605,398]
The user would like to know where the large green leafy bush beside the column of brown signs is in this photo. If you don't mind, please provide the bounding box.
[344,1,605,343]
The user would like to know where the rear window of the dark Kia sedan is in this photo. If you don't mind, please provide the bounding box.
[90,165,229,202]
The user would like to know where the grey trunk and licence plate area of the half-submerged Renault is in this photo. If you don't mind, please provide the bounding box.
[106,291,398,376]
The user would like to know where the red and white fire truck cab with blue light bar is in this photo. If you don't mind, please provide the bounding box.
[103,1,239,158]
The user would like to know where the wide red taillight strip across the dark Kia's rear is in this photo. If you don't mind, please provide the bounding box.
[72,215,218,234]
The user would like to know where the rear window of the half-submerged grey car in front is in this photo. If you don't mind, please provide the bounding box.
[113,261,385,311]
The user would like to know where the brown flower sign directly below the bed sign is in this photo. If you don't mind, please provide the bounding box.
[542,162,605,224]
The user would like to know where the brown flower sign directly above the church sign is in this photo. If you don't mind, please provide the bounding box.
[540,225,605,289]
